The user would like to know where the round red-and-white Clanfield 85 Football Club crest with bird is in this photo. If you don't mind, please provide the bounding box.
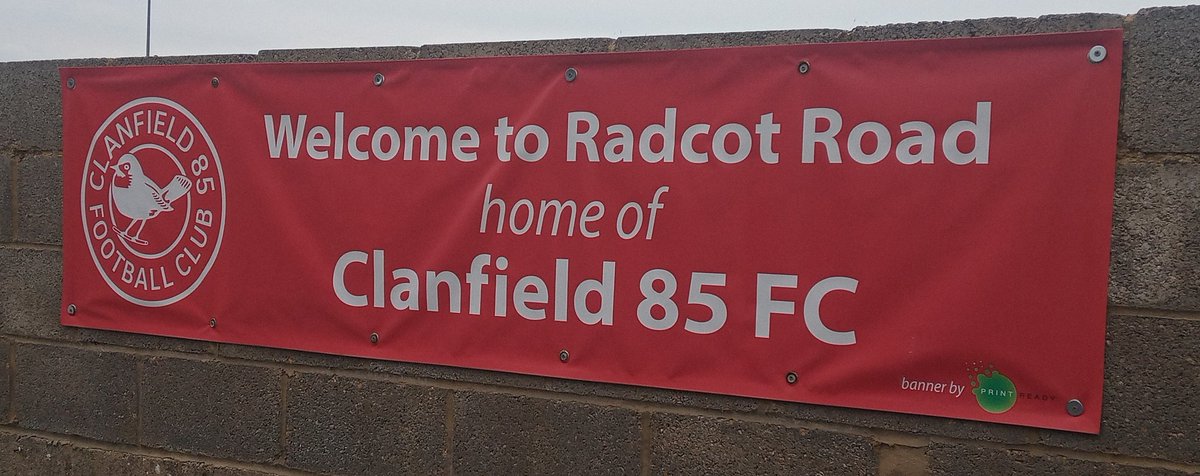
[79,97,226,307]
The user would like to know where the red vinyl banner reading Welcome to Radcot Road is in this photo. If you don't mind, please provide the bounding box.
[61,31,1122,433]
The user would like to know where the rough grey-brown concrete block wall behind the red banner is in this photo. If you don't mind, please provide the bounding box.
[0,6,1200,475]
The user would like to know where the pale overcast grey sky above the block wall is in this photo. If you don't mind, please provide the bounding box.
[0,0,1186,61]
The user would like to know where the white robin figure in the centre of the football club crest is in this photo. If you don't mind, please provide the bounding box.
[109,153,192,245]
